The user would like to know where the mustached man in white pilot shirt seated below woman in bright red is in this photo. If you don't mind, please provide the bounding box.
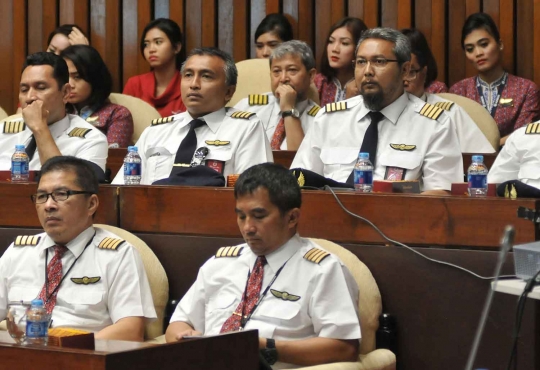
[113,48,273,185]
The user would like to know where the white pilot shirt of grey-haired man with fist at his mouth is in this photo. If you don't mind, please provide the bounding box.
[234,92,321,150]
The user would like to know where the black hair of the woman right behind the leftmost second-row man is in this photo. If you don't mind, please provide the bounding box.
[60,45,112,110]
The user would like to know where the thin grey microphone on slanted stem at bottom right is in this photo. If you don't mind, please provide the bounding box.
[465,225,516,370]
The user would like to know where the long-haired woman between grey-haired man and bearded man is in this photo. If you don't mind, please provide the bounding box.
[314,17,367,106]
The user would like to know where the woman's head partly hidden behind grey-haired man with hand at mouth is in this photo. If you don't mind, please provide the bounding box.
[255,13,293,59]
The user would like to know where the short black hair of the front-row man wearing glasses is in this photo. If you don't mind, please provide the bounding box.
[40,155,99,194]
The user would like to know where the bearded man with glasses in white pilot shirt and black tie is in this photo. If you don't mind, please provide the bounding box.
[291,28,463,195]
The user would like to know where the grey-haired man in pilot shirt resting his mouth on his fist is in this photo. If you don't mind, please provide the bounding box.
[235,40,320,150]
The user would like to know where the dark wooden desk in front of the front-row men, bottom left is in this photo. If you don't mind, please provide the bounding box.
[0,330,259,370]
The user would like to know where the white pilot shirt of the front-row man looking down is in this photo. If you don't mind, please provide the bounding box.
[171,235,361,369]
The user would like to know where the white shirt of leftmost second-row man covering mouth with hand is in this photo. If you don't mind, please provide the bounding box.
[0,114,109,171]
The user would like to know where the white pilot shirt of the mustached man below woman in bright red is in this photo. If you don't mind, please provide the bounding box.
[112,108,273,185]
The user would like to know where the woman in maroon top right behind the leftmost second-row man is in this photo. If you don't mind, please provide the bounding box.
[60,45,133,148]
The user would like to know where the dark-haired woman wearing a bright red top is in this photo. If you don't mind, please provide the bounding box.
[123,18,186,117]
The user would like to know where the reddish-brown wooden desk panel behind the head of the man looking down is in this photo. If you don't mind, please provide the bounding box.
[120,186,540,248]
